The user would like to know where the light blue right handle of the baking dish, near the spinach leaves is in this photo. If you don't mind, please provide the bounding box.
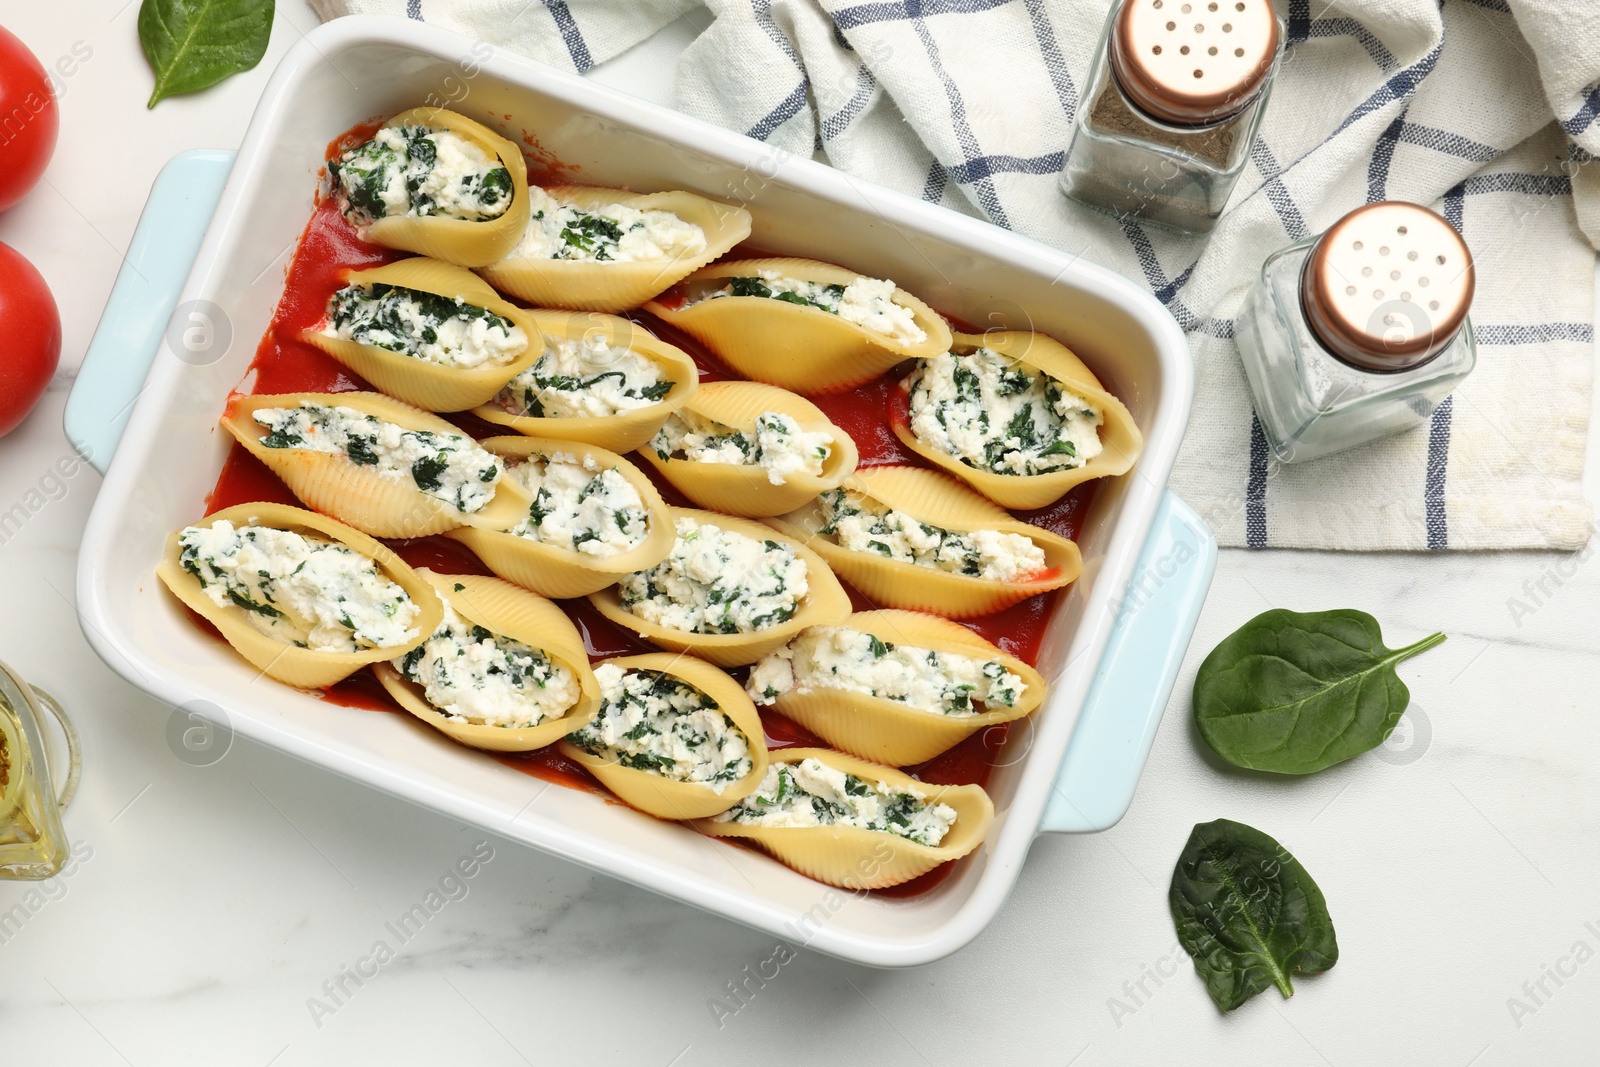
[1038,491,1216,833]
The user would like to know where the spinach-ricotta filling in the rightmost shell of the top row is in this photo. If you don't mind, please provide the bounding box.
[906,349,1106,475]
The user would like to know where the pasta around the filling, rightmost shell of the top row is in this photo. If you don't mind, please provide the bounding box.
[890,330,1144,510]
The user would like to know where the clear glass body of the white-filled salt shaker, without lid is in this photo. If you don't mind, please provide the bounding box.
[1235,223,1477,462]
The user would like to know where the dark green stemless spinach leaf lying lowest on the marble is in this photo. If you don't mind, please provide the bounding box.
[1166,819,1339,1011]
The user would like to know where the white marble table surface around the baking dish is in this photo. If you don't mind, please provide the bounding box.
[0,0,1600,1067]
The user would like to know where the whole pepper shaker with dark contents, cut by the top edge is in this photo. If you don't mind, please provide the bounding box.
[1061,0,1283,234]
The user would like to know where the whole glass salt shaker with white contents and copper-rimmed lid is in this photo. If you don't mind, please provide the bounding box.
[1235,202,1477,462]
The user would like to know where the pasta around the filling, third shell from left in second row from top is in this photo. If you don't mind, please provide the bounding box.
[638,382,859,518]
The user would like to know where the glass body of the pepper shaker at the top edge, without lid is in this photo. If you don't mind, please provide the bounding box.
[1061,0,1282,234]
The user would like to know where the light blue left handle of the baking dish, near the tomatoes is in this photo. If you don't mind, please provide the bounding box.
[62,149,235,474]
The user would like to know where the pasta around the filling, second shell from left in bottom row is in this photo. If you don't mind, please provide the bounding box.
[373,568,600,752]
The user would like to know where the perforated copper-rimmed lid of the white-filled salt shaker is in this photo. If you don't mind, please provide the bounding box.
[1301,200,1477,371]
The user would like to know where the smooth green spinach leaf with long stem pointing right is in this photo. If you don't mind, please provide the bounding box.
[1194,609,1445,774]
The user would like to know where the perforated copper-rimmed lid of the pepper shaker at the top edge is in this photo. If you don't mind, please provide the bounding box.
[1110,0,1278,126]
